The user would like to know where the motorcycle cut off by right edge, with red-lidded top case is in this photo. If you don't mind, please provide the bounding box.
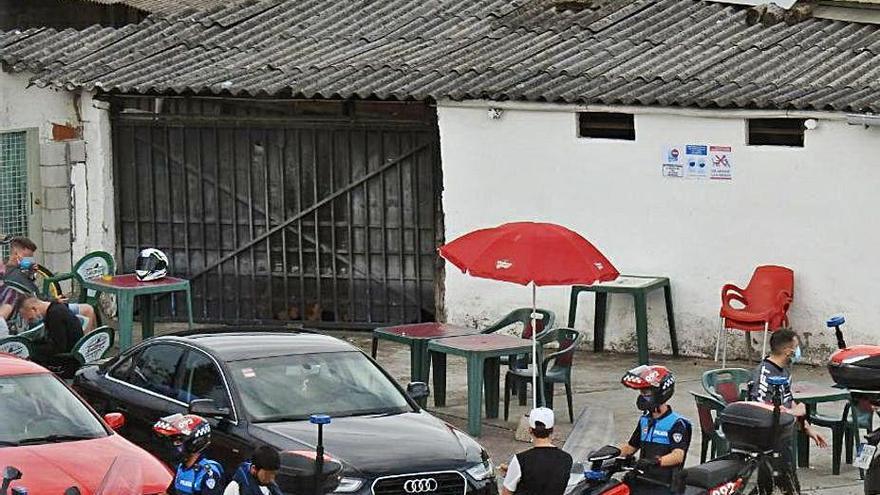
[826,316,880,495]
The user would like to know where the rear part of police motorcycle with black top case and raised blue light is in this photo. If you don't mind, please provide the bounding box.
[672,377,800,495]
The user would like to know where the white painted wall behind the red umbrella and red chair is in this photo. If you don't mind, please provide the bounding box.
[438,102,880,358]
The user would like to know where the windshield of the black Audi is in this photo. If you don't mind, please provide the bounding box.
[229,351,411,422]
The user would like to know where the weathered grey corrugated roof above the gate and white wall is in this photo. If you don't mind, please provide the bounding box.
[0,0,880,112]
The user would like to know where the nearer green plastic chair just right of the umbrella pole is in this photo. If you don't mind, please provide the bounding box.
[504,328,584,423]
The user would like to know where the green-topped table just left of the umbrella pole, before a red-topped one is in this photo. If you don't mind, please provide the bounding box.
[428,333,543,436]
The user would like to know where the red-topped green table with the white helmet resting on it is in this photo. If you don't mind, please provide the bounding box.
[82,274,192,351]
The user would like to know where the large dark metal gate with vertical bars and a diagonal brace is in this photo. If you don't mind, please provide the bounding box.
[113,98,443,327]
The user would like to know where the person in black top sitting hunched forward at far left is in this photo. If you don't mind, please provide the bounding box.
[19,296,83,376]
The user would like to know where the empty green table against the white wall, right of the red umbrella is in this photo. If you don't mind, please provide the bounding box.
[568,275,678,364]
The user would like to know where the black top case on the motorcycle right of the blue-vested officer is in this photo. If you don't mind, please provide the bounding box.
[720,401,795,451]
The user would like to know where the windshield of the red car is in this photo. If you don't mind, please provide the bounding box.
[0,374,107,448]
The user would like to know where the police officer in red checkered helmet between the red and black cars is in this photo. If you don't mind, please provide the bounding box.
[153,414,223,495]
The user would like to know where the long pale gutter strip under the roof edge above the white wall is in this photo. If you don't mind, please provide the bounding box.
[437,99,852,121]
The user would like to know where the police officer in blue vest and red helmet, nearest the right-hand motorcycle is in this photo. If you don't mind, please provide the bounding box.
[620,365,692,495]
